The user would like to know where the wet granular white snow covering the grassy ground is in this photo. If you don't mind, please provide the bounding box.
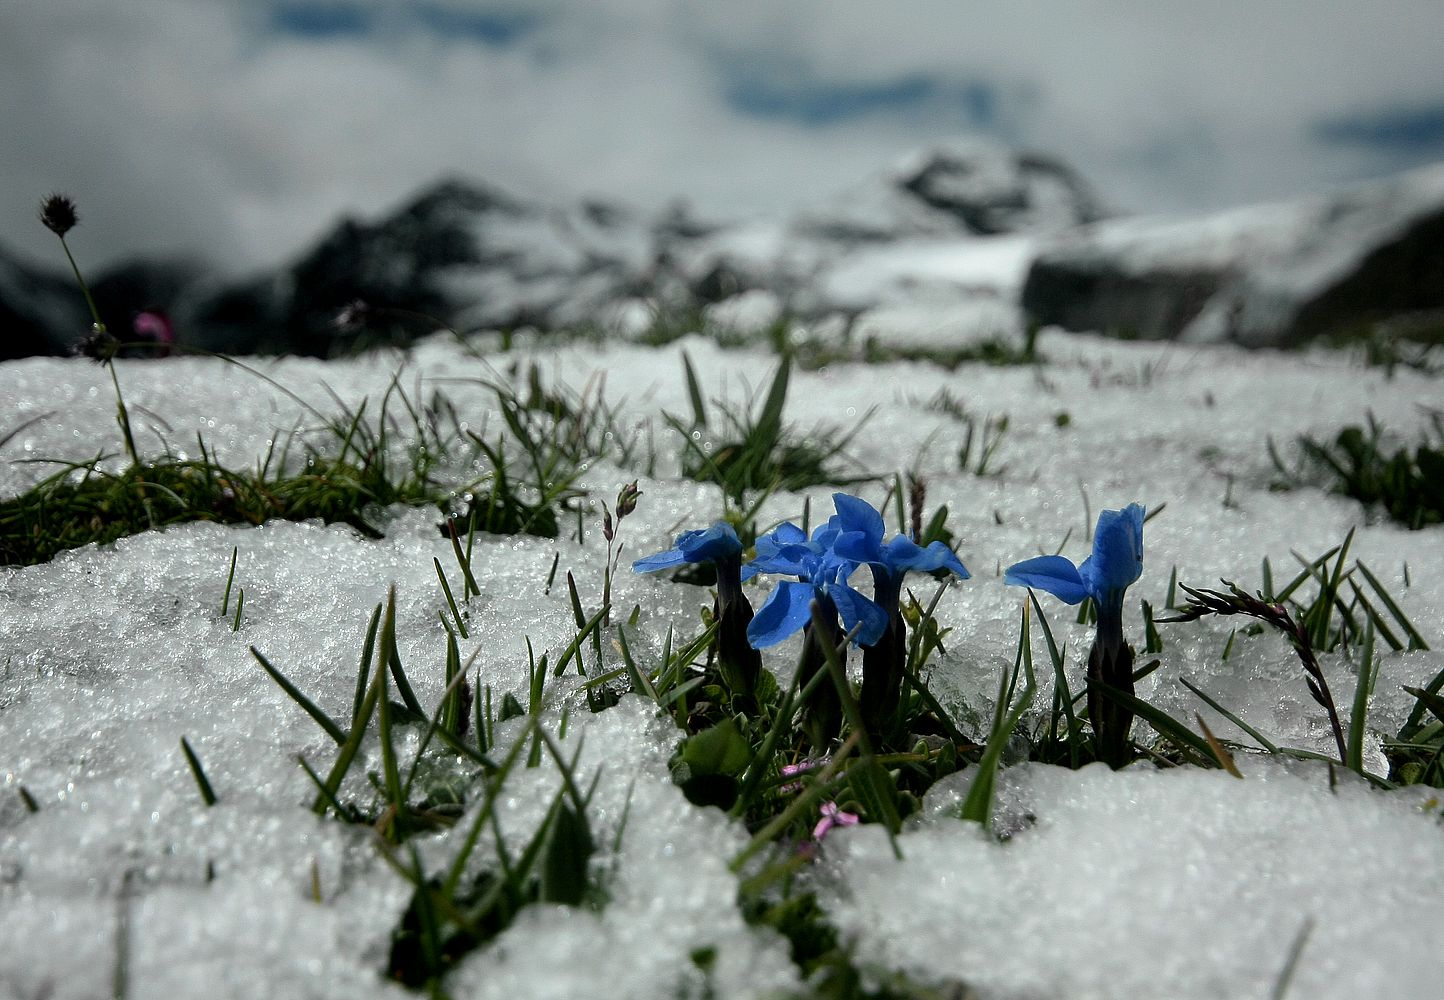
[0,333,1444,1000]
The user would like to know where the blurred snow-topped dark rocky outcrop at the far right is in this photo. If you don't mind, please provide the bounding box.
[1022,167,1444,346]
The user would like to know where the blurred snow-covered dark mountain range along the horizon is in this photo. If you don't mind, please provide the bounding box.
[8,141,1444,356]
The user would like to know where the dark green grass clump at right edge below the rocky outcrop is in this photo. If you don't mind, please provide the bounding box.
[1269,410,1444,531]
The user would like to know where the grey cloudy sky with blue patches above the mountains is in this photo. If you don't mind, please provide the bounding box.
[8,0,1444,271]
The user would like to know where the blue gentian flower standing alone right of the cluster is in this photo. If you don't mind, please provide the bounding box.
[1004,504,1144,768]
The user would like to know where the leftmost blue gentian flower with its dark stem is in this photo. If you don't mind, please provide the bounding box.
[632,521,762,711]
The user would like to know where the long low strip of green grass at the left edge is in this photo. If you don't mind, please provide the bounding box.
[0,359,600,566]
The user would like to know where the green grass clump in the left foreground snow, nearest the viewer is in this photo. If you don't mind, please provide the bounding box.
[254,589,622,993]
